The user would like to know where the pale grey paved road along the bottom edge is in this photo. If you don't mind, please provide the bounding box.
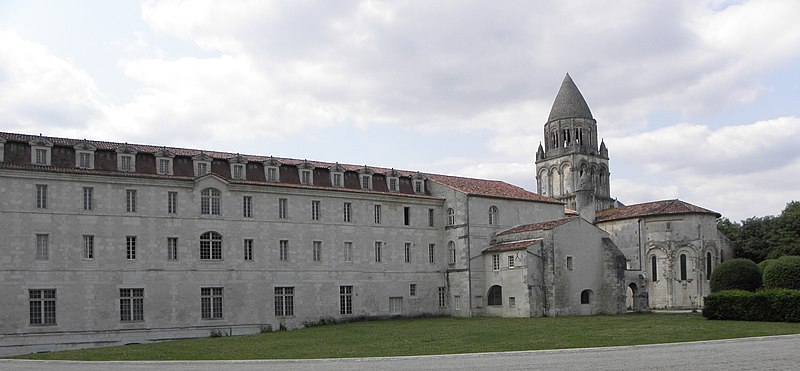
[0,335,800,371]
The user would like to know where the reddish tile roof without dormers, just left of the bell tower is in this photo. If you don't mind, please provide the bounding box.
[428,174,563,204]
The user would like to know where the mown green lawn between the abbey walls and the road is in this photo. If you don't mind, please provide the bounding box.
[14,314,800,361]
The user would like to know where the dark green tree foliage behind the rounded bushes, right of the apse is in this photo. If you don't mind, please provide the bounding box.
[717,201,800,262]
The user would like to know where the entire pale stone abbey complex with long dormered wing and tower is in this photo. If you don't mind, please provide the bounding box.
[0,75,731,355]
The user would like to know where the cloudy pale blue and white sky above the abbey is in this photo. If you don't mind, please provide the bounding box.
[0,0,800,221]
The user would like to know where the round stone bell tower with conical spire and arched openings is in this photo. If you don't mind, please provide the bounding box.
[536,74,614,210]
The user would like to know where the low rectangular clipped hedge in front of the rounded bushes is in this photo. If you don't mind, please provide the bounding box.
[703,289,800,322]
